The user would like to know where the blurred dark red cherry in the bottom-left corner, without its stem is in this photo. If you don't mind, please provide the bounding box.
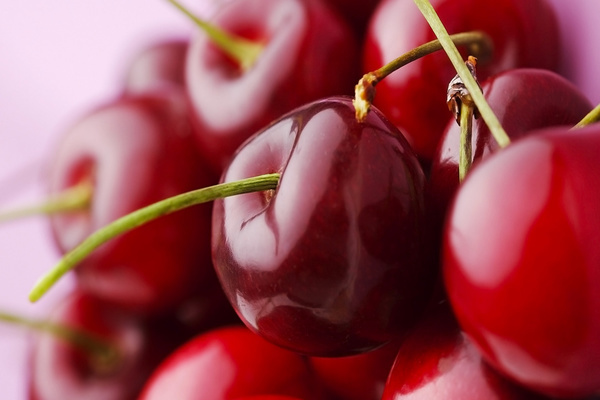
[28,292,182,400]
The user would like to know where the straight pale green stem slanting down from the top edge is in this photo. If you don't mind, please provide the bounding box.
[414,0,510,147]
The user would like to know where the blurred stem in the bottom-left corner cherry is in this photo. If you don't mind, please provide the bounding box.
[0,311,121,368]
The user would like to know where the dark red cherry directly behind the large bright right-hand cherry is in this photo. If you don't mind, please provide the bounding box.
[427,68,592,231]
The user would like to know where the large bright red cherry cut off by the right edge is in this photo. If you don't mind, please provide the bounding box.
[443,124,600,397]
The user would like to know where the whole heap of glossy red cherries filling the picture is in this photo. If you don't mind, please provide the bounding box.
[4,0,600,400]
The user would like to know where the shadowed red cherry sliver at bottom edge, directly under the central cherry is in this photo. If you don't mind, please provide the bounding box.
[310,340,401,400]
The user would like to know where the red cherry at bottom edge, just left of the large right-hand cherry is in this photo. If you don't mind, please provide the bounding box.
[381,309,545,400]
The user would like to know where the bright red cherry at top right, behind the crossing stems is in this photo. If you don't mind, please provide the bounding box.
[363,0,560,163]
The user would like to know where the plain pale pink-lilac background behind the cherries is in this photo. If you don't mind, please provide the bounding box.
[0,0,600,399]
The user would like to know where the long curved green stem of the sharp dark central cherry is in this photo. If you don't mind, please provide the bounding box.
[29,173,279,302]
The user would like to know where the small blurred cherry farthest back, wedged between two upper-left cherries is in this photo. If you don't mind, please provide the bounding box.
[123,38,189,94]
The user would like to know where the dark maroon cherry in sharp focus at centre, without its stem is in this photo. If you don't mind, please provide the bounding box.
[212,97,436,356]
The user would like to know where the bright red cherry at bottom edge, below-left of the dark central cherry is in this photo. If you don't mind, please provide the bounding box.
[140,326,321,400]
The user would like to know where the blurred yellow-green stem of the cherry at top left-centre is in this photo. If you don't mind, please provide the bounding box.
[168,0,264,71]
